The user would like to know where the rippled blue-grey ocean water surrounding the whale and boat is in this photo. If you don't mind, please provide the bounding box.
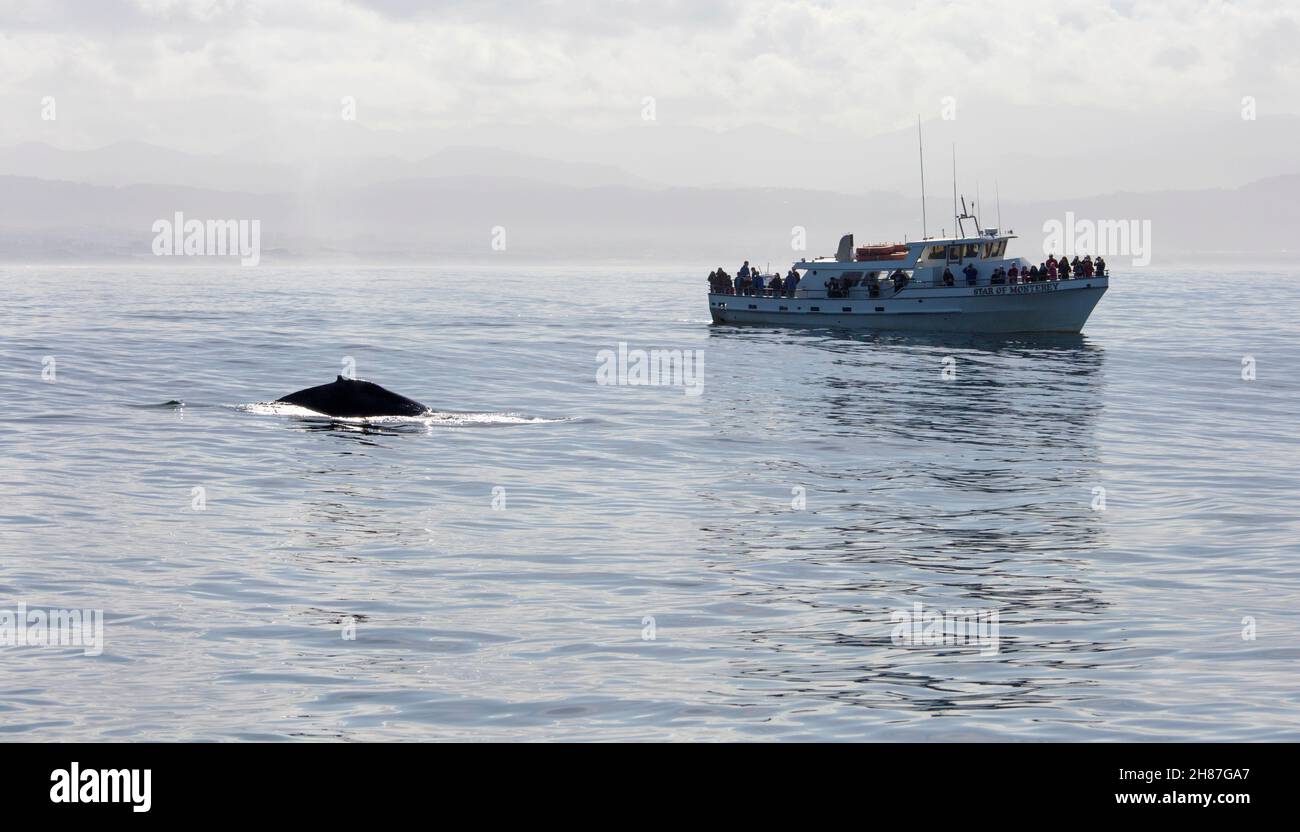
[0,265,1300,741]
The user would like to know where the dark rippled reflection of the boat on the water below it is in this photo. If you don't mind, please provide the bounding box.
[701,328,1122,733]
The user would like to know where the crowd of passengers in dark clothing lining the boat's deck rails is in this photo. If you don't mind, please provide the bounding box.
[709,255,1106,298]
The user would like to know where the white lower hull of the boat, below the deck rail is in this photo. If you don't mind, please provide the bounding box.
[709,277,1109,333]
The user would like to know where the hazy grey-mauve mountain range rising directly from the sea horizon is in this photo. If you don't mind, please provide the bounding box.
[0,136,1300,269]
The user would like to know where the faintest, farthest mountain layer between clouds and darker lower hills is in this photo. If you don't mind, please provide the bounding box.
[10,103,1300,197]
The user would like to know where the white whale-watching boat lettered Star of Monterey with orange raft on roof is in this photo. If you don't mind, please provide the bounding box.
[709,227,1110,333]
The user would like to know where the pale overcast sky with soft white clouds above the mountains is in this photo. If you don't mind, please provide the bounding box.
[0,0,1300,151]
